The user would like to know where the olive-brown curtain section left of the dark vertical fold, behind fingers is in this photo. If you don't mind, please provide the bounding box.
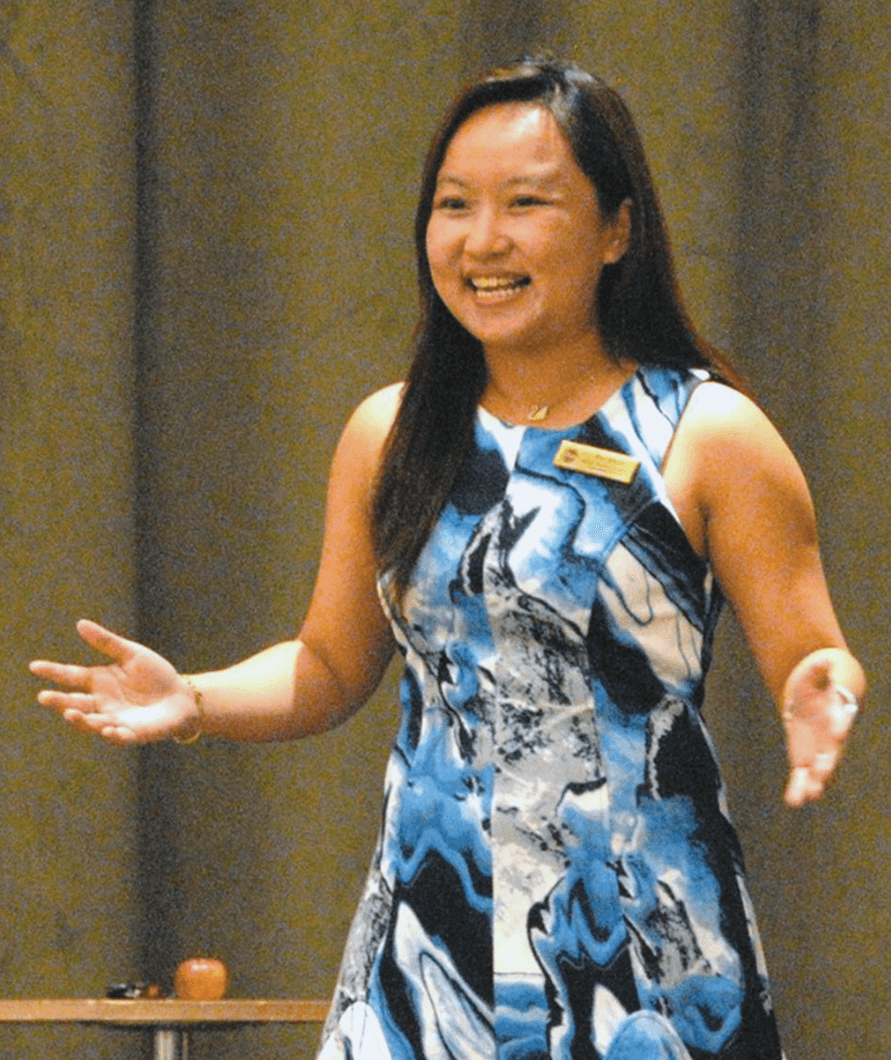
[0,3,139,1060]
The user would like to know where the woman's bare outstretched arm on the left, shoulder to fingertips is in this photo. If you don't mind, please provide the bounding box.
[31,386,399,744]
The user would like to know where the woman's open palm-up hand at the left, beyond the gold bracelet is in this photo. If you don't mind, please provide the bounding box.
[30,619,198,746]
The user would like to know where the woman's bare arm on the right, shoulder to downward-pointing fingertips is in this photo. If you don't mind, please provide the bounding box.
[665,383,866,806]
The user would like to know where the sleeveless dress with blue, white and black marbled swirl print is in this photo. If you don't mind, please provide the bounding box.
[319,368,782,1060]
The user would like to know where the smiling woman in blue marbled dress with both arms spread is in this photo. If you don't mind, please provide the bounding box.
[32,61,865,1060]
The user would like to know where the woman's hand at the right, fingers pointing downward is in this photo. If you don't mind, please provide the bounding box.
[783,652,859,807]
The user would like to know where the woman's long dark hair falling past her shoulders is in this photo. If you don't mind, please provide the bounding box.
[372,59,742,599]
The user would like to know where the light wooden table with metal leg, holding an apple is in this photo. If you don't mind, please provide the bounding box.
[0,997,328,1060]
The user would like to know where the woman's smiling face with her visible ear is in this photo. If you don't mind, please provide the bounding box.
[427,103,630,353]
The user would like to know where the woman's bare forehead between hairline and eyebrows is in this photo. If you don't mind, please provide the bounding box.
[438,103,588,183]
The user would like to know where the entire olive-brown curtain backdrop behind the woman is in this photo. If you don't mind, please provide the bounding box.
[0,0,891,1060]
